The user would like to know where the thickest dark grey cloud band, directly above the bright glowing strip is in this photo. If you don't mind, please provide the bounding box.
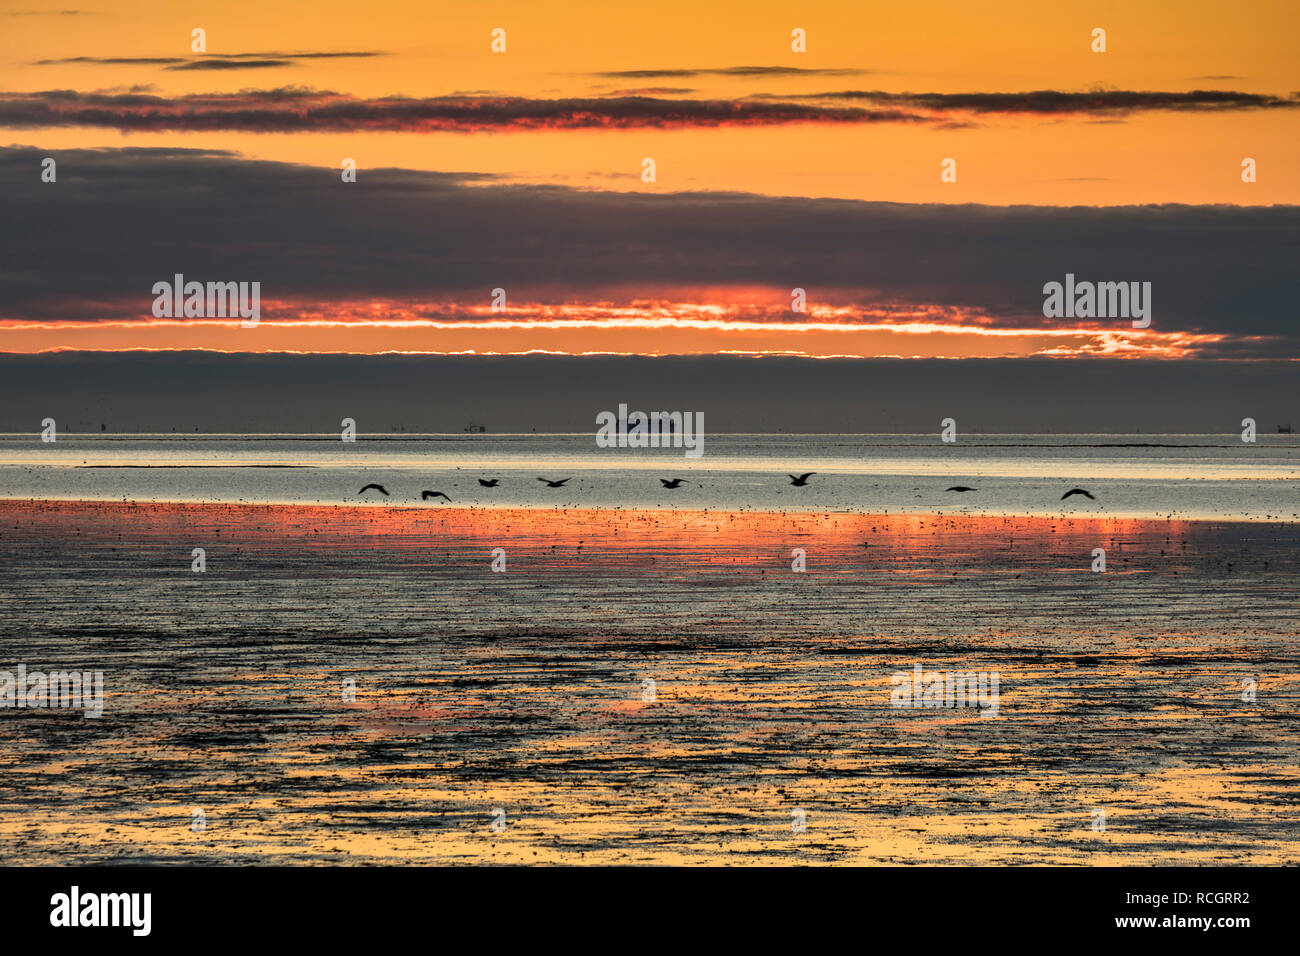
[0,147,1300,358]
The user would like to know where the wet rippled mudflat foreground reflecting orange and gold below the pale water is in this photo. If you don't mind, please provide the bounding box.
[0,501,1300,865]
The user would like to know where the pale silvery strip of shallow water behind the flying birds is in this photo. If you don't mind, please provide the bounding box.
[0,434,1300,520]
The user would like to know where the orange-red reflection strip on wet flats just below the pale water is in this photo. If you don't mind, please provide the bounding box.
[0,499,1200,564]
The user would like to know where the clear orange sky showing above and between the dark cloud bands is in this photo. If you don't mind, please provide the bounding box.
[0,0,1300,356]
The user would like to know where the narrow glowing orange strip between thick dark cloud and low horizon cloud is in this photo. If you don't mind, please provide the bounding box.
[0,307,1226,359]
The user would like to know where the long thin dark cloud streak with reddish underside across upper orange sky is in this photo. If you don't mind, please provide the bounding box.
[0,85,1300,133]
